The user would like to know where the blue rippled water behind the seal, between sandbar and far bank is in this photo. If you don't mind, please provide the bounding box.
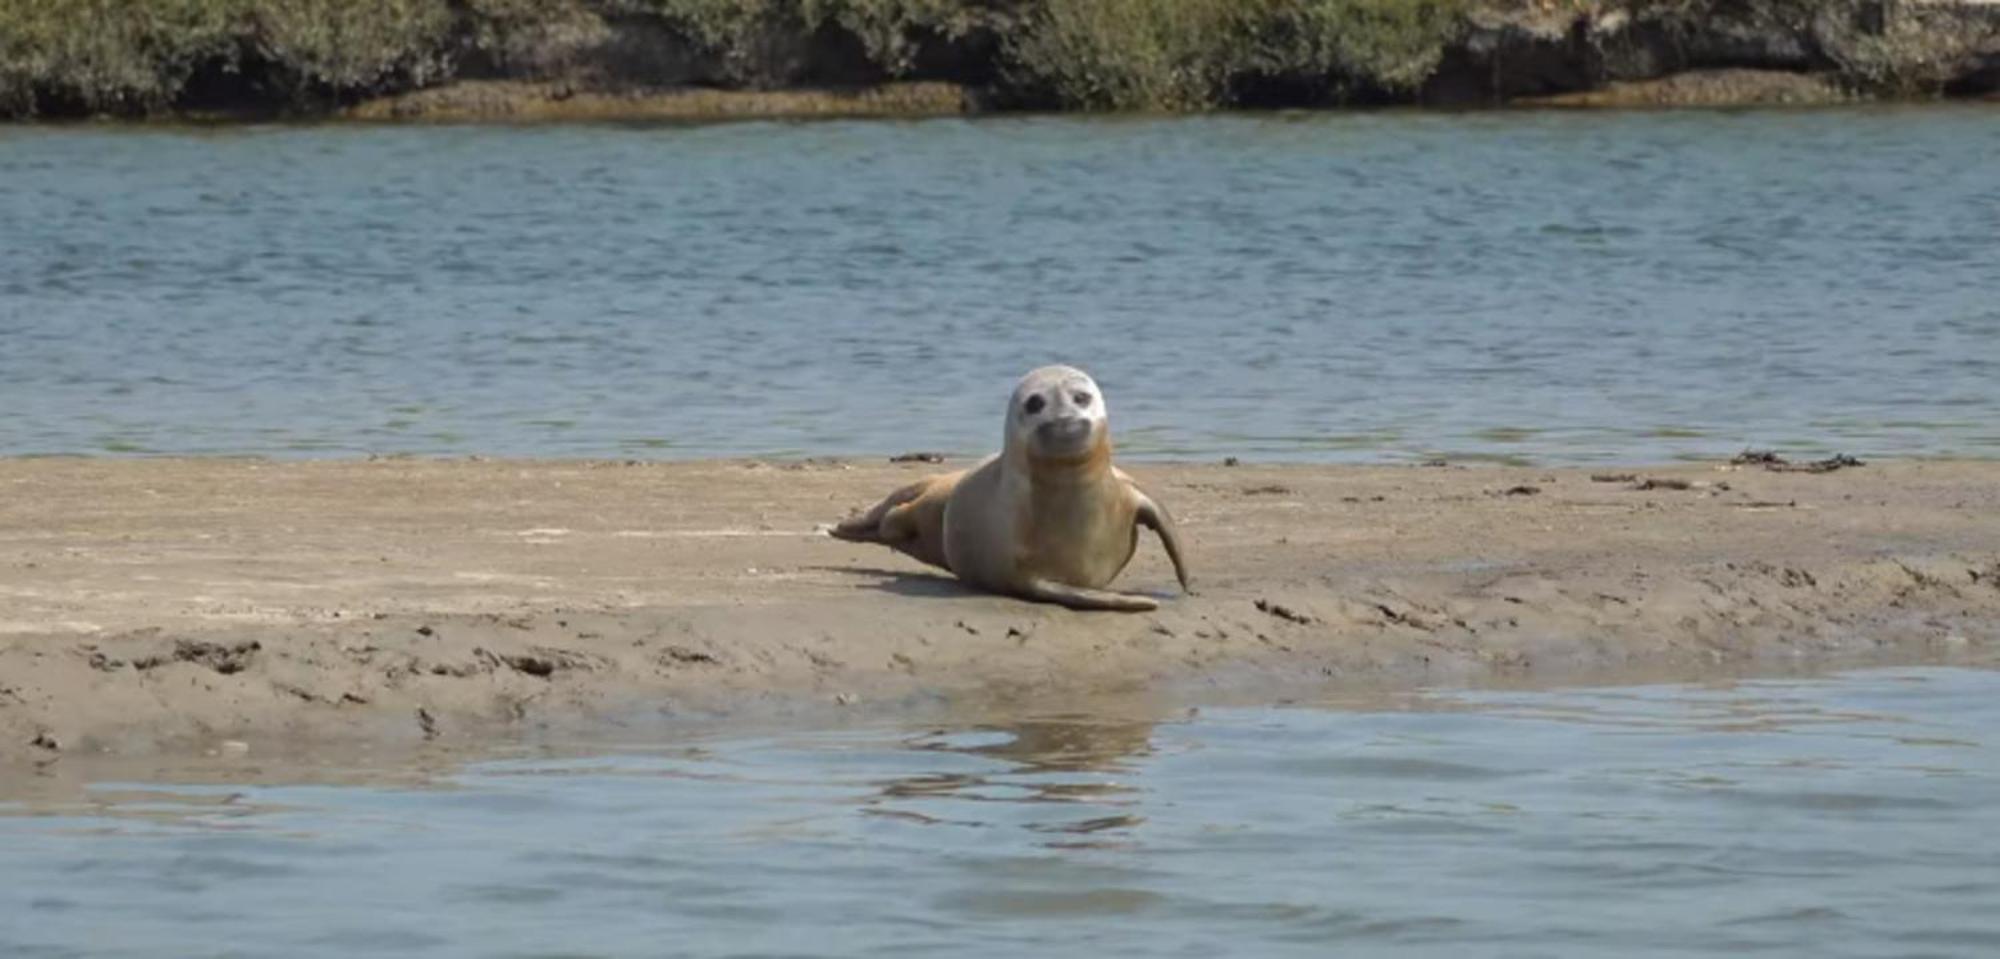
[0,108,2000,462]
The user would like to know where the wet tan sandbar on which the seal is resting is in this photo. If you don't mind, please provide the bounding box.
[0,458,2000,765]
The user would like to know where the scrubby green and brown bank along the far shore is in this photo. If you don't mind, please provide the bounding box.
[0,0,2000,118]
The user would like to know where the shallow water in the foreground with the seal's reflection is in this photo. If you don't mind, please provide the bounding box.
[0,669,2000,959]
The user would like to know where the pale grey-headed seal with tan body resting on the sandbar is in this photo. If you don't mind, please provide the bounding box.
[832,366,1192,611]
